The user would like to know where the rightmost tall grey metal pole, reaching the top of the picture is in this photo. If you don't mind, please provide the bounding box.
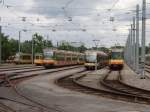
[141,0,146,79]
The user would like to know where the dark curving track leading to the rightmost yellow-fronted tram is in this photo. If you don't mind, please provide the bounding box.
[100,71,150,104]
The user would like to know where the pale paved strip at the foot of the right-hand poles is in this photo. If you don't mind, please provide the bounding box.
[122,65,150,90]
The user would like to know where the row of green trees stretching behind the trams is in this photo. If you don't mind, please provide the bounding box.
[0,33,87,60]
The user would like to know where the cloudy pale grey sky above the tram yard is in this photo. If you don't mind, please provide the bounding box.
[0,0,150,47]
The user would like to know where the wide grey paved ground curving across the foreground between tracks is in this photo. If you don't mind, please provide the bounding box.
[16,67,150,112]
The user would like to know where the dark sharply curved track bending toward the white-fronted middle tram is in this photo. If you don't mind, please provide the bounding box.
[55,71,120,98]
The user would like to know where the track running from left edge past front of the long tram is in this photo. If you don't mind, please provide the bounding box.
[0,66,82,86]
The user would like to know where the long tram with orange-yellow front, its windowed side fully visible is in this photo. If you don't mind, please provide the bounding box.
[43,49,84,68]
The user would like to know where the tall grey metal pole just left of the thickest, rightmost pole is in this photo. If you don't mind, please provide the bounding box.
[136,5,139,73]
